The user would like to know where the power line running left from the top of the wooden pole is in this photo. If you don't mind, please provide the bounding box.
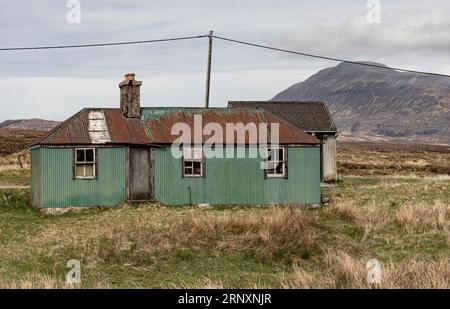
[0,35,208,51]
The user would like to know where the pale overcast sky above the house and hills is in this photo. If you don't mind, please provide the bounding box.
[0,0,450,122]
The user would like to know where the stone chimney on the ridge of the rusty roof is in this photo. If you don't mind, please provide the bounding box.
[119,73,142,118]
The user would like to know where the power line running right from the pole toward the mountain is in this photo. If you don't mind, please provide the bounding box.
[213,35,450,77]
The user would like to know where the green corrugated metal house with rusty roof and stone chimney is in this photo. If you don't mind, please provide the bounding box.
[31,74,321,208]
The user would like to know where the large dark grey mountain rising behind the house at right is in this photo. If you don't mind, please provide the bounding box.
[272,63,450,144]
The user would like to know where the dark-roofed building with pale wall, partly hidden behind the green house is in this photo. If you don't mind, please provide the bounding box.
[228,101,338,184]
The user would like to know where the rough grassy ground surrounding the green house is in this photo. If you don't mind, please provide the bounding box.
[0,141,450,288]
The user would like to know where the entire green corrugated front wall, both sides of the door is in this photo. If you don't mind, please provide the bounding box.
[31,147,320,208]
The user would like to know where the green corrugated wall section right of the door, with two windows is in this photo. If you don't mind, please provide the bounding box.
[155,147,320,205]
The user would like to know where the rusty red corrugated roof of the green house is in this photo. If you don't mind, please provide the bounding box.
[33,108,320,145]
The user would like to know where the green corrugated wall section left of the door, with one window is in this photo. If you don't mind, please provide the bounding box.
[32,148,126,208]
